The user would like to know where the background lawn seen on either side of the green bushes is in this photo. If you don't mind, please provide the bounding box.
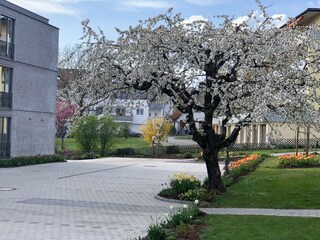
[56,138,149,151]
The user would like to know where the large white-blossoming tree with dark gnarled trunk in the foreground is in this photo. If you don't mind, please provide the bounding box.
[77,2,319,191]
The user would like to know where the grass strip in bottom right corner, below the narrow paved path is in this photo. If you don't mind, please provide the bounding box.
[201,215,320,240]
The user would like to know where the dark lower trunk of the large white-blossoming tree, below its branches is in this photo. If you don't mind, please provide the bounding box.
[203,150,225,193]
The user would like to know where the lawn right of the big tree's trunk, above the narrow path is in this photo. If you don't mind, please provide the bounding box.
[213,158,320,209]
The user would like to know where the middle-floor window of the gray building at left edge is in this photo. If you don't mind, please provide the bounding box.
[0,66,12,108]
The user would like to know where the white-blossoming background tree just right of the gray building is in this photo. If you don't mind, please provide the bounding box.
[58,46,114,116]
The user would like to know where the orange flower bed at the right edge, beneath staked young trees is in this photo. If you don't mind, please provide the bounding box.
[278,153,320,168]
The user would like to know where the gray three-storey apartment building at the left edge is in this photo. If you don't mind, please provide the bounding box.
[0,0,59,158]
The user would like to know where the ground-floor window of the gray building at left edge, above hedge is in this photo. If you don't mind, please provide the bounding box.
[0,117,11,158]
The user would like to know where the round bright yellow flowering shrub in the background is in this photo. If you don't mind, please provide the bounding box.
[140,117,172,146]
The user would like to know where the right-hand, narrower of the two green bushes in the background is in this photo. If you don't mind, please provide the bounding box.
[99,117,119,152]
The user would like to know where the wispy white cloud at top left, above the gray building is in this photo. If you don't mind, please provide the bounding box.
[8,0,103,15]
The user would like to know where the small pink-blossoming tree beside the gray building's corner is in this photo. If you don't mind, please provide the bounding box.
[56,100,76,149]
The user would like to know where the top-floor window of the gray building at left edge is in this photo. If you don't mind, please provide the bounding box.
[0,15,14,59]
